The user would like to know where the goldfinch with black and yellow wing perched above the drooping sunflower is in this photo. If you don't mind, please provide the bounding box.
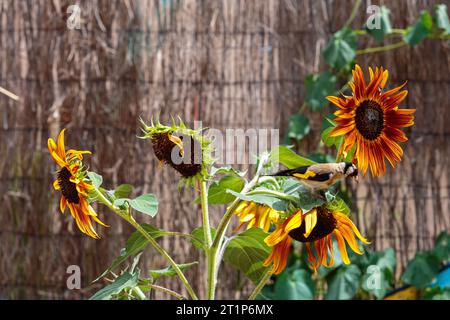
[271,162,358,193]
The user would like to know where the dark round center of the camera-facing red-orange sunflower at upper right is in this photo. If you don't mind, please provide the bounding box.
[355,100,384,140]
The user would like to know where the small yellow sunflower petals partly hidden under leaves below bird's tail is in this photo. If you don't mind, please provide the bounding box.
[234,201,280,232]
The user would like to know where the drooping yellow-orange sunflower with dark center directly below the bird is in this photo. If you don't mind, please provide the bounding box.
[264,206,369,274]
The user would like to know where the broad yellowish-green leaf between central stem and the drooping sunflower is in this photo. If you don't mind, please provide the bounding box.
[224,228,270,284]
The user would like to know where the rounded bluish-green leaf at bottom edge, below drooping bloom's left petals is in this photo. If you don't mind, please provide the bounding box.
[274,269,316,300]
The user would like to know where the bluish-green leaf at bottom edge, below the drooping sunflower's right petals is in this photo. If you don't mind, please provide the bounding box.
[325,264,361,300]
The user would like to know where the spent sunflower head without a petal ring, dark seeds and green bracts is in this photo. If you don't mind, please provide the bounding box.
[140,119,213,184]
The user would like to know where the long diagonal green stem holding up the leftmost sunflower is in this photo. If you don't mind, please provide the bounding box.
[93,188,198,300]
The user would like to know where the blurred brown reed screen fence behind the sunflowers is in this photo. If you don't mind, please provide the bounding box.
[0,0,450,299]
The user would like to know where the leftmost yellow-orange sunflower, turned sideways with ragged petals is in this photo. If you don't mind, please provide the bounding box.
[48,129,107,239]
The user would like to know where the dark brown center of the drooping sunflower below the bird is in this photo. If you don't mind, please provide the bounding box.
[289,208,337,242]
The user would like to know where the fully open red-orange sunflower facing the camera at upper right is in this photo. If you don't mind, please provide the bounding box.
[327,65,416,176]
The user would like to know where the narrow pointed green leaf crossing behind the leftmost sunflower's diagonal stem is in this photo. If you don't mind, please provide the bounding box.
[94,223,166,282]
